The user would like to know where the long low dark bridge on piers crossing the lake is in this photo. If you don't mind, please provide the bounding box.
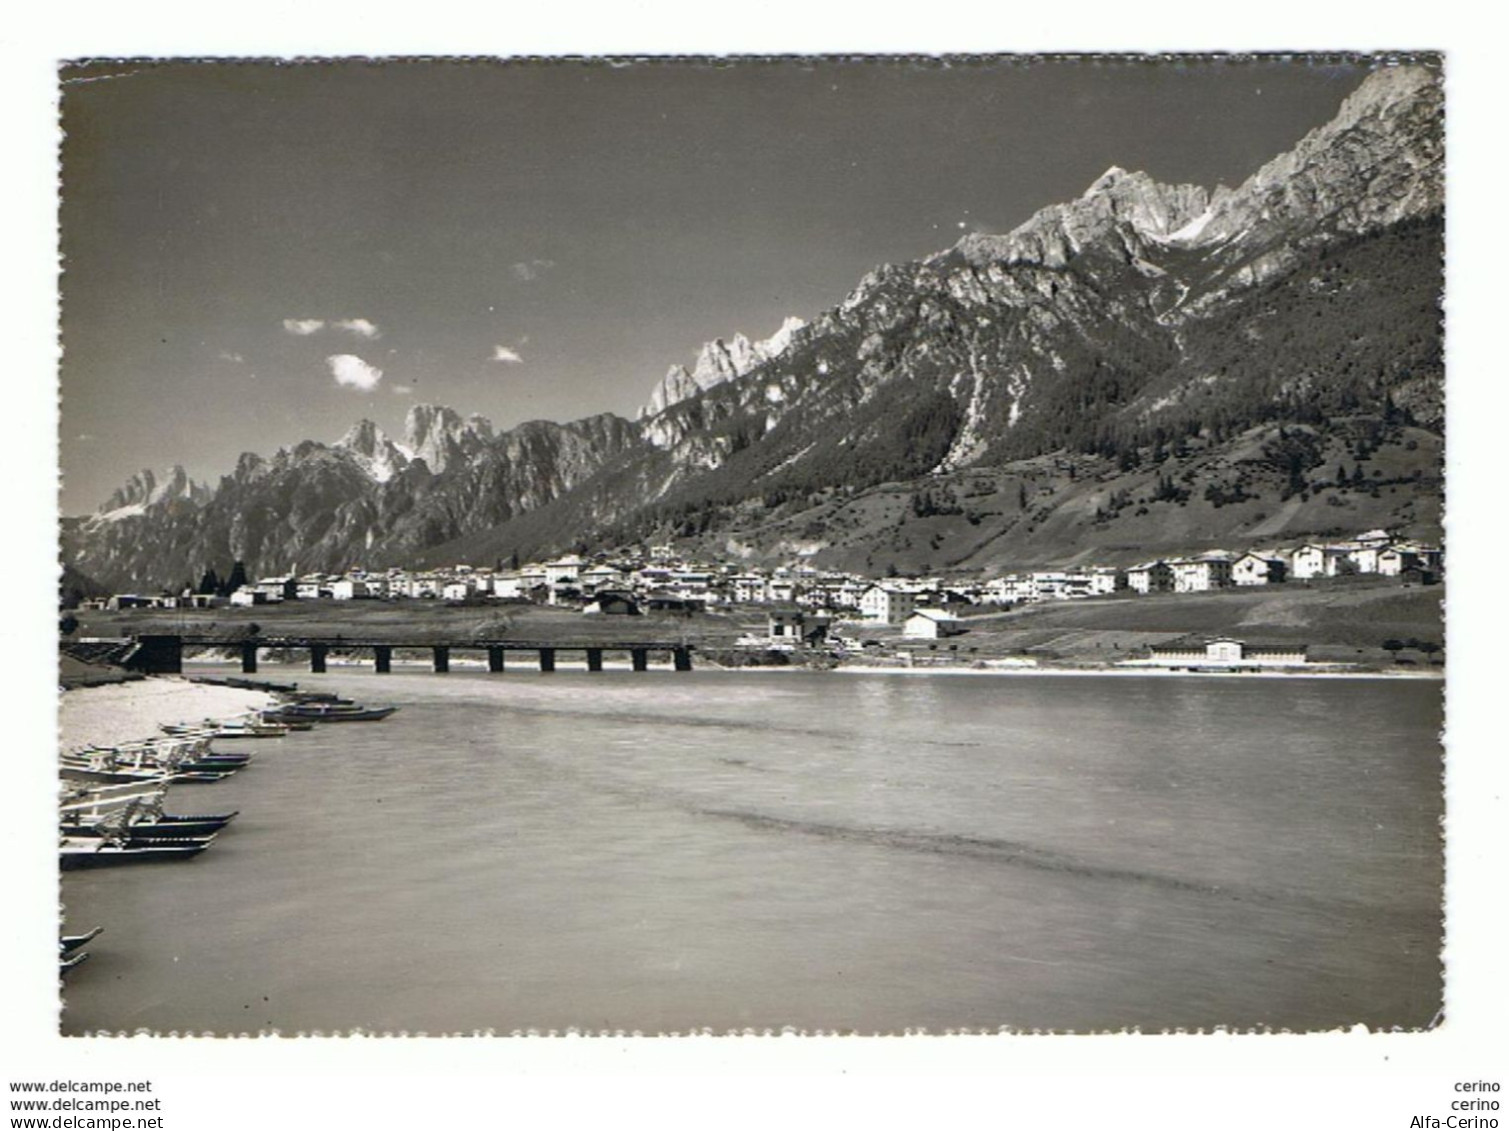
[127,635,693,674]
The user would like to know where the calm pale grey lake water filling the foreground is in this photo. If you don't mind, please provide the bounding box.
[62,670,1443,1034]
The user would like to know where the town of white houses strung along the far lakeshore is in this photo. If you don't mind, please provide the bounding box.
[78,529,1444,671]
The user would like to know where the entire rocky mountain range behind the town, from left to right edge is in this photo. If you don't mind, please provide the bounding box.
[69,68,1443,594]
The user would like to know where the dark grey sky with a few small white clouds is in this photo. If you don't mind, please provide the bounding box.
[59,59,1382,514]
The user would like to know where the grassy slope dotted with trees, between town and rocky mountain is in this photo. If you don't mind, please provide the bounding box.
[666,418,1443,576]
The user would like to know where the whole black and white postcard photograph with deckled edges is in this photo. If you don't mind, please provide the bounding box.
[50,53,1449,1034]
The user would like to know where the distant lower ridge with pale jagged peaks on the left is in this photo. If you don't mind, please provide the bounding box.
[63,406,641,590]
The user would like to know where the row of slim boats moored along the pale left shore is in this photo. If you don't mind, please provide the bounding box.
[57,692,397,971]
